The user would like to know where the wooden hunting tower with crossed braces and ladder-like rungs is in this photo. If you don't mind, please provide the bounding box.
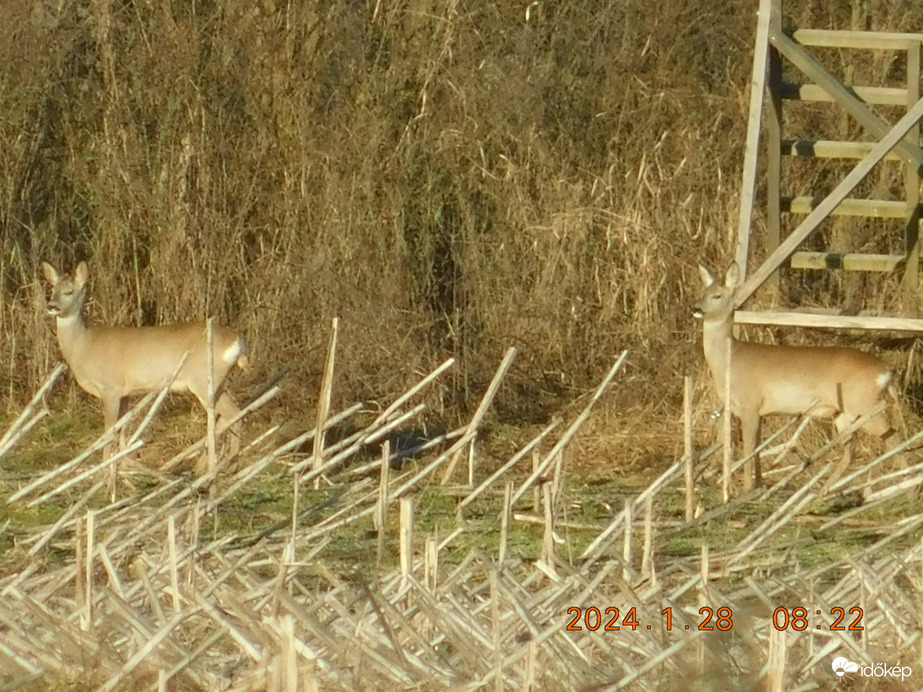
[735,0,923,332]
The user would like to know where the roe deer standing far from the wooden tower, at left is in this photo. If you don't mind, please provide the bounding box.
[42,262,248,470]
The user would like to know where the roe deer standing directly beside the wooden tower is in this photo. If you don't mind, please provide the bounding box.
[693,263,893,490]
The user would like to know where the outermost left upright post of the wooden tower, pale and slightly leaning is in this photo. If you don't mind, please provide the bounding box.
[736,0,773,276]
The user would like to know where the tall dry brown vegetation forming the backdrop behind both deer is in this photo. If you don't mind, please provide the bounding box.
[0,0,923,684]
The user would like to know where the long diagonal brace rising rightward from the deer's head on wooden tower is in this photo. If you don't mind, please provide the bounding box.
[735,94,923,307]
